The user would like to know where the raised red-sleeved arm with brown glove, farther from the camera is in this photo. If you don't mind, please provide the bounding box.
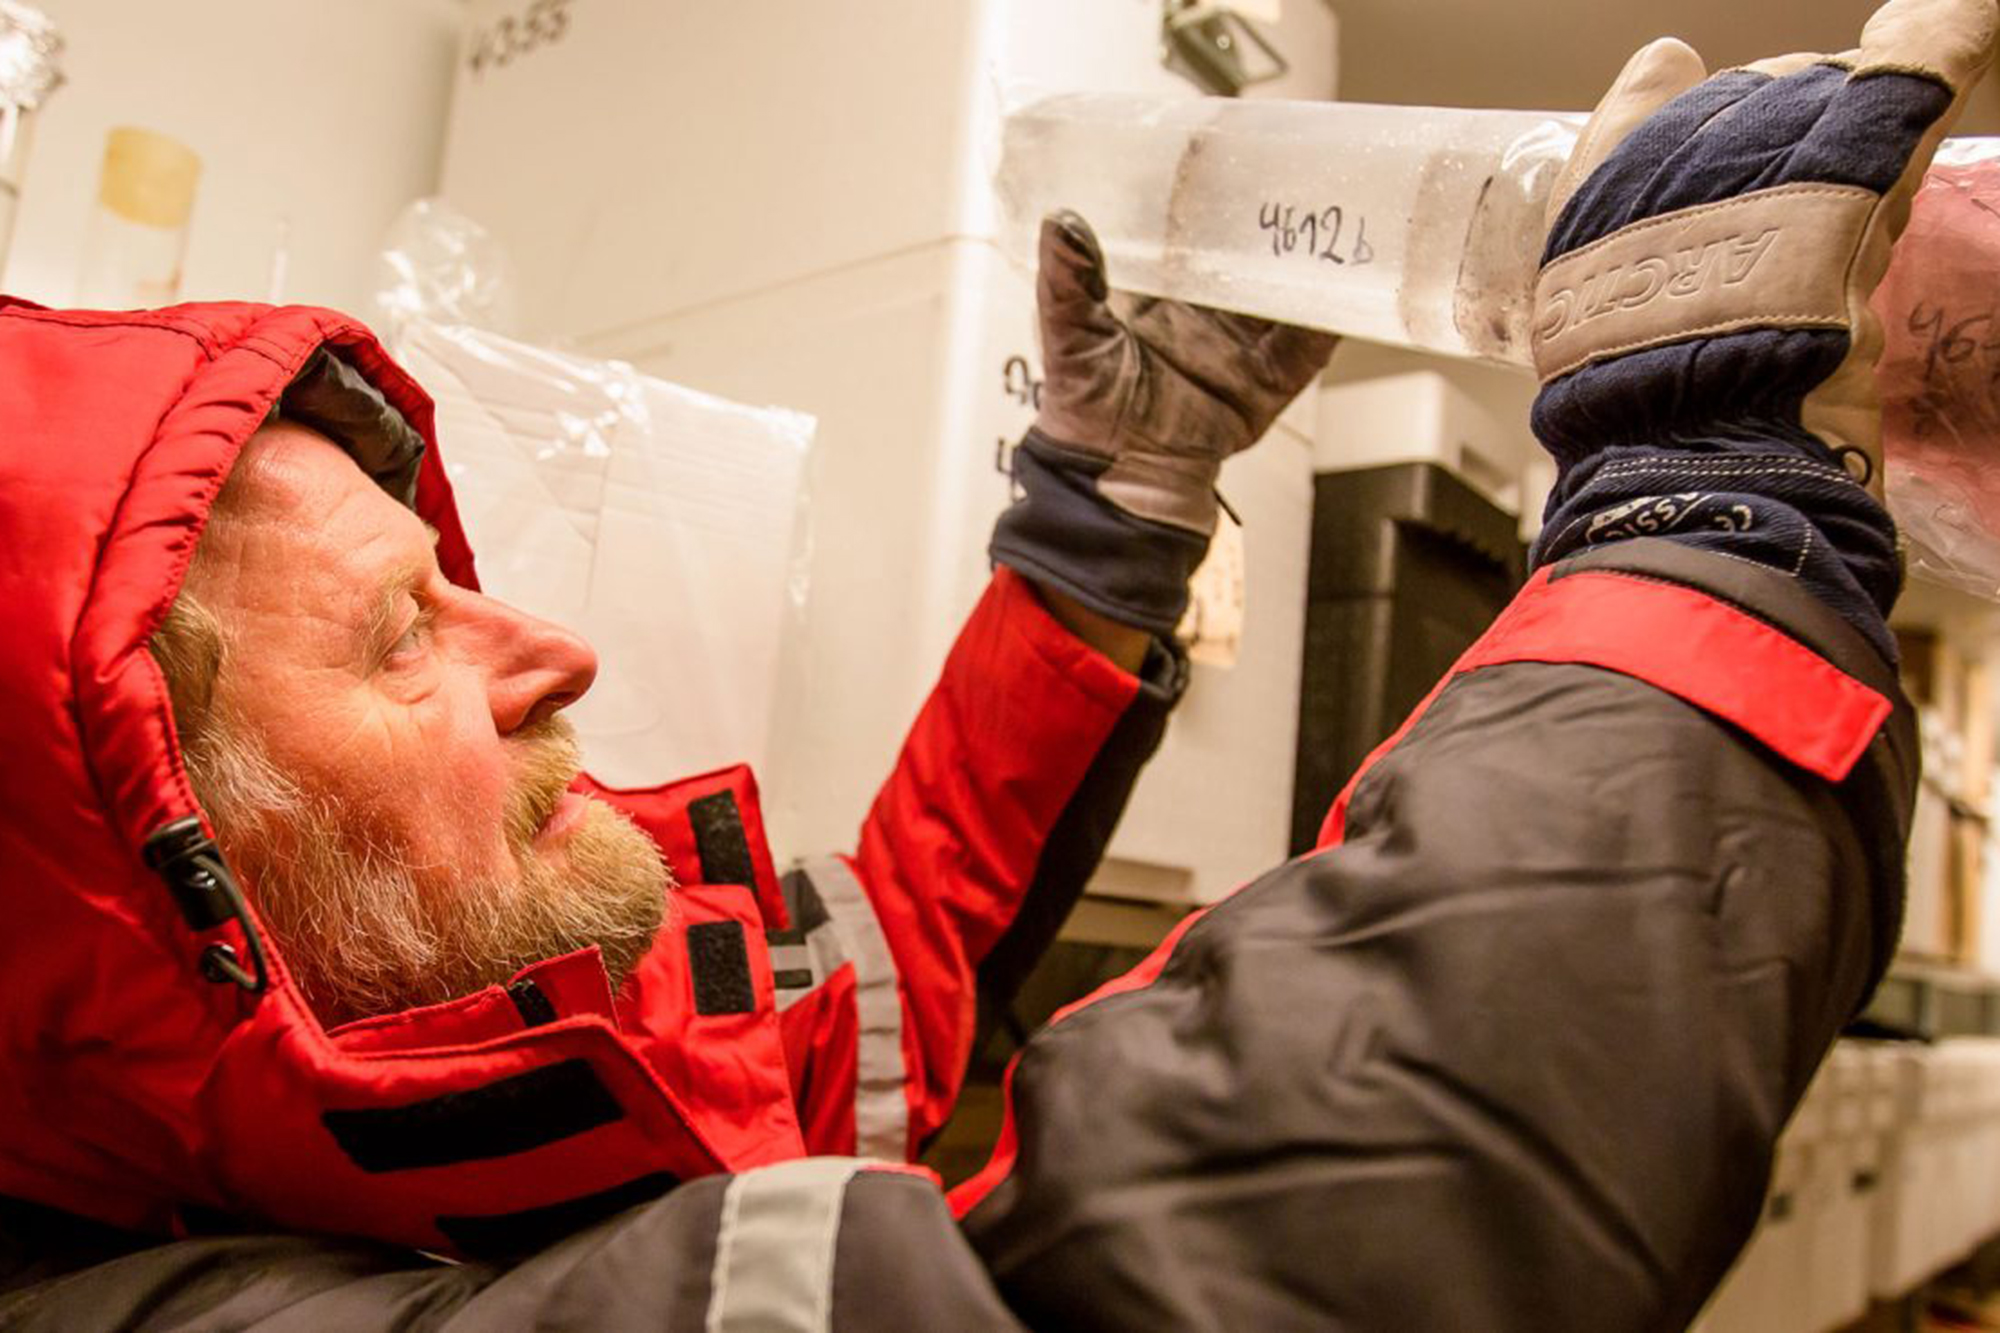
[780,214,1334,1157]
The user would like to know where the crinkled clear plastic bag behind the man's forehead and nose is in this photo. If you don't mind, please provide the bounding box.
[384,202,814,787]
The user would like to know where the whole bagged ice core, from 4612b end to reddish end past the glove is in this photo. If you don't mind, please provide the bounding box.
[996,94,2000,600]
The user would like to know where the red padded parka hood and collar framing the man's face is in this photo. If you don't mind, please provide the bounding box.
[0,300,798,1251]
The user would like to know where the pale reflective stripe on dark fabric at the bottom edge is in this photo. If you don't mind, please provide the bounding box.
[706,1157,864,1333]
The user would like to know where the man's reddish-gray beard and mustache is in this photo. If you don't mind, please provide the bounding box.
[186,717,674,1027]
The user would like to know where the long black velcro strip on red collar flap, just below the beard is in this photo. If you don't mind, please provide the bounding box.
[320,1059,624,1171]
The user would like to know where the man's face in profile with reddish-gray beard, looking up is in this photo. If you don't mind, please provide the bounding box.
[186,424,670,1023]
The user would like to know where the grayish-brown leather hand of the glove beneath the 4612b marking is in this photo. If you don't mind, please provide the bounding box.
[1034,212,1336,538]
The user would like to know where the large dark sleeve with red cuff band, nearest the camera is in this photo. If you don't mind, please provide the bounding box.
[952,542,1914,1333]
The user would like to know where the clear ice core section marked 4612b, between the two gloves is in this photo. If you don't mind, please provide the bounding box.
[998,94,2000,364]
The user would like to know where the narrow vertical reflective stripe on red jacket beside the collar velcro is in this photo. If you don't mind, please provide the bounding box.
[804,857,910,1161]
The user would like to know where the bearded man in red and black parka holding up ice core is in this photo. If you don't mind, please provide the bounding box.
[0,0,1996,1329]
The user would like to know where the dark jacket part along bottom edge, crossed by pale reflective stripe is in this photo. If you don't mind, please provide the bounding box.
[0,1159,1020,1333]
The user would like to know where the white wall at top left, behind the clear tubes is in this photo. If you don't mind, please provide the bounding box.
[4,0,462,316]
